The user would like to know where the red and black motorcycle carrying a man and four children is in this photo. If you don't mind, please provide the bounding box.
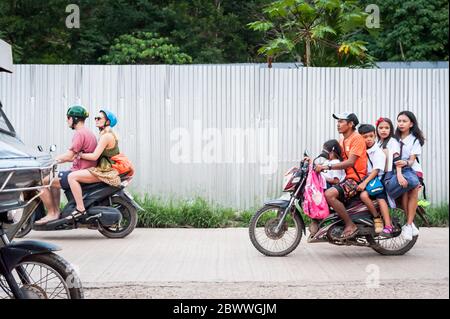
[249,151,426,256]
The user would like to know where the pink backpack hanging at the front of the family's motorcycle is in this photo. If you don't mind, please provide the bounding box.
[302,165,330,219]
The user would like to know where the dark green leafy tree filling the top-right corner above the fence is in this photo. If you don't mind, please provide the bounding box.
[354,0,449,61]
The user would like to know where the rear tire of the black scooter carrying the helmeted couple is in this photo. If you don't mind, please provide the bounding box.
[98,196,137,239]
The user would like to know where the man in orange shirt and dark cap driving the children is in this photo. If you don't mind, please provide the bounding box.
[316,112,367,239]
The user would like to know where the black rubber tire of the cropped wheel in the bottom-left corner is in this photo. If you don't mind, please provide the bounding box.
[0,253,84,299]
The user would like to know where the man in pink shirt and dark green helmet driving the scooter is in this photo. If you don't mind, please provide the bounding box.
[36,105,97,225]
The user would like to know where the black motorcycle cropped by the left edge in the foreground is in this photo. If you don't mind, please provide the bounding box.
[0,185,84,299]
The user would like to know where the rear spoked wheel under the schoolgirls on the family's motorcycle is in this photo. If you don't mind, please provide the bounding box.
[371,207,421,256]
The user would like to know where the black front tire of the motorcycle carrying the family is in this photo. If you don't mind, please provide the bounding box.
[249,206,303,257]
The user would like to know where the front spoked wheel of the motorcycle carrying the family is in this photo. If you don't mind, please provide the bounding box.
[249,206,303,257]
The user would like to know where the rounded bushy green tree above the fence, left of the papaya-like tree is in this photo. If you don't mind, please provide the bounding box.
[100,32,192,64]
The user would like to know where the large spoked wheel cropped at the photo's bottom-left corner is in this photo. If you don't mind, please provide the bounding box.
[0,253,83,299]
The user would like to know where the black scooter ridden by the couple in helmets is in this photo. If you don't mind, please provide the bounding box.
[16,146,142,238]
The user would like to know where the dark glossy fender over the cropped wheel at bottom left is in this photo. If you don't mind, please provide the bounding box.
[0,240,61,272]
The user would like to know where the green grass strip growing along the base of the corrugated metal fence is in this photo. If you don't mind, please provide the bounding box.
[134,195,449,228]
